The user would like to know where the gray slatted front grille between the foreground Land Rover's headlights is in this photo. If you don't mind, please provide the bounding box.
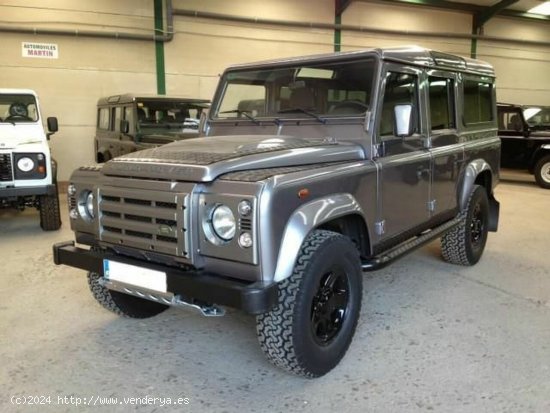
[99,187,189,258]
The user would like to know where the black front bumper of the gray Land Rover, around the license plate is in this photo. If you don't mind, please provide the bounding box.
[53,241,277,314]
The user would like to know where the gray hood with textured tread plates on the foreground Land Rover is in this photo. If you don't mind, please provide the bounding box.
[102,135,365,182]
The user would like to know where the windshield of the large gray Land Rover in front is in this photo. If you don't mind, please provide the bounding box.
[213,59,375,121]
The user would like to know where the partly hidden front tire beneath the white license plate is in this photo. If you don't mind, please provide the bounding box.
[88,272,168,318]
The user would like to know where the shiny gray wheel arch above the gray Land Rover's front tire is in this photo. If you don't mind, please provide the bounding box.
[273,193,370,282]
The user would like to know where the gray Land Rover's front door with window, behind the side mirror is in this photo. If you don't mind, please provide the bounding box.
[376,65,431,242]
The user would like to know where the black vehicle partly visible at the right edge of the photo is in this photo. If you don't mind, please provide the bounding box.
[497,103,550,189]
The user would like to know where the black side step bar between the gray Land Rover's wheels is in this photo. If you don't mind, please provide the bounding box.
[361,218,461,271]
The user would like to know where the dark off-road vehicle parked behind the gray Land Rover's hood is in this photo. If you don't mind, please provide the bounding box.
[95,93,210,163]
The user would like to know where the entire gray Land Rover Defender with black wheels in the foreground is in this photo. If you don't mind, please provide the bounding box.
[54,48,500,377]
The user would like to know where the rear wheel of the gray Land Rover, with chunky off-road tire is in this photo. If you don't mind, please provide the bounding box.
[441,185,489,265]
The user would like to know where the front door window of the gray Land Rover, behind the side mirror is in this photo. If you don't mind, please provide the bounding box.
[380,72,419,136]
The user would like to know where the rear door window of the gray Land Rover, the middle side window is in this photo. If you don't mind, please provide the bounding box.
[428,76,456,131]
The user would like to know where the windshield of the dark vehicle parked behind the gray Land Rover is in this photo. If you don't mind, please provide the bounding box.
[137,100,208,133]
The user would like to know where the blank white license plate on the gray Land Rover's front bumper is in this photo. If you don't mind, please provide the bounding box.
[103,260,167,293]
